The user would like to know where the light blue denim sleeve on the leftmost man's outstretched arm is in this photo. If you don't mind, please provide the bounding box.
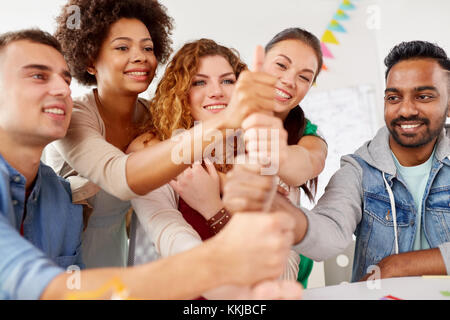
[0,212,64,300]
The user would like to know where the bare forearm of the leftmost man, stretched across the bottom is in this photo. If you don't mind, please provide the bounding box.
[41,245,225,300]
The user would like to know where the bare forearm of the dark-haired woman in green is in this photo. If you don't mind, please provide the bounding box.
[278,145,326,186]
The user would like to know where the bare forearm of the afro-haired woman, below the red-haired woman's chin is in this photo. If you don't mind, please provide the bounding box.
[126,118,224,195]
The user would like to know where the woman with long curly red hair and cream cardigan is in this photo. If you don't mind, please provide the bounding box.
[129,39,300,299]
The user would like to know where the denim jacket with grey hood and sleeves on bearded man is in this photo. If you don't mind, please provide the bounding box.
[296,127,450,281]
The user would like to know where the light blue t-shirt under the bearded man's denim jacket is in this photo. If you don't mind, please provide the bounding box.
[392,150,434,250]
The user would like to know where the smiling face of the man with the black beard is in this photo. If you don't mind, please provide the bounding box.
[384,59,450,148]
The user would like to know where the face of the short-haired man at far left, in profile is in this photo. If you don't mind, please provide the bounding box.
[0,40,72,146]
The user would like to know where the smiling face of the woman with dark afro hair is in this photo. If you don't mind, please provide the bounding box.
[88,18,158,94]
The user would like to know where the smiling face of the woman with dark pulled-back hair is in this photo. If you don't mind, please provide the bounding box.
[263,40,319,116]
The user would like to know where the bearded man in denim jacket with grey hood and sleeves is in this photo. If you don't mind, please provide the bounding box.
[224,41,450,281]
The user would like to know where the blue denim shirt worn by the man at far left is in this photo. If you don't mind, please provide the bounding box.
[0,155,84,300]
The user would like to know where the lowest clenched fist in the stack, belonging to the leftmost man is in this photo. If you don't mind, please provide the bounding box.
[208,212,295,285]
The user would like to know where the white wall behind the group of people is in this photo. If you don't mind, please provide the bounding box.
[0,0,450,287]
